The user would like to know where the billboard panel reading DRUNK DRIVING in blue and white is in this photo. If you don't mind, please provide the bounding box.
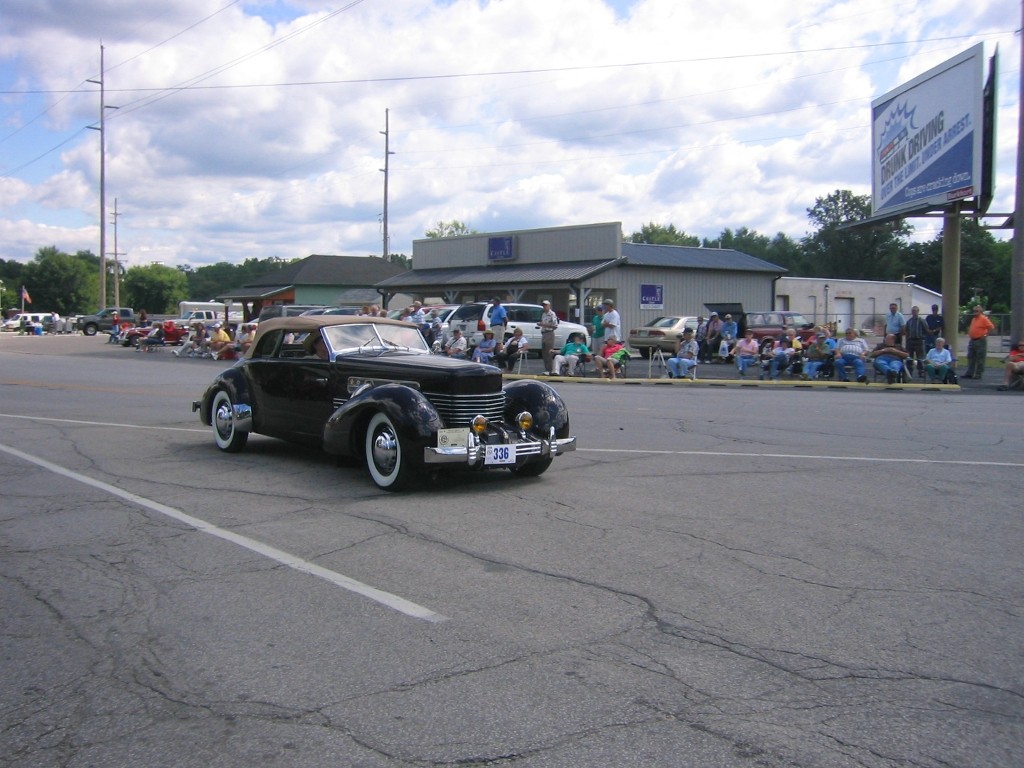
[871,43,984,216]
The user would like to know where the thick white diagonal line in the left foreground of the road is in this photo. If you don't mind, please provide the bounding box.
[0,444,447,622]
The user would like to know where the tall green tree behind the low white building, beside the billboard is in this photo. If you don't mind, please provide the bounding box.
[802,189,912,280]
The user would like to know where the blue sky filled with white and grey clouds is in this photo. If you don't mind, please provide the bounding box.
[0,0,1020,266]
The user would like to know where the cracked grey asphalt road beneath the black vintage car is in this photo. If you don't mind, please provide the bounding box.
[0,334,1024,768]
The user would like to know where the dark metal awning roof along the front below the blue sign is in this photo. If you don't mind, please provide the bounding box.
[377,259,622,289]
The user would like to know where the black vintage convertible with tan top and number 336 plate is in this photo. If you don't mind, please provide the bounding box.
[193,314,575,490]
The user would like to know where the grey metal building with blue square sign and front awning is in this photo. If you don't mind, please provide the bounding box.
[376,221,785,330]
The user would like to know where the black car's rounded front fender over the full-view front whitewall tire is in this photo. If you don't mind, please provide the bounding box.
[324,383,444,463]
